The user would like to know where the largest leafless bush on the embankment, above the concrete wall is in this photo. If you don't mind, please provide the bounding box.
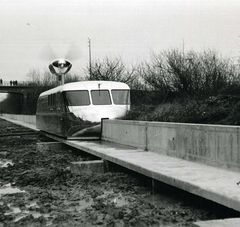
[142,50,239,97]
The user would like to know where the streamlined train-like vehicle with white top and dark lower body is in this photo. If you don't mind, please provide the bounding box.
[36,81,130,138]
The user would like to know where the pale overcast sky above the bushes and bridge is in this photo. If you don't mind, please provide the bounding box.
[0,0,240,80]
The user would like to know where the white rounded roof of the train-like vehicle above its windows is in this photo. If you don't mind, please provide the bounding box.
[40,80,129,96]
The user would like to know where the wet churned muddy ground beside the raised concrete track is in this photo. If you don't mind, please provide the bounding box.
[0,120,239,227]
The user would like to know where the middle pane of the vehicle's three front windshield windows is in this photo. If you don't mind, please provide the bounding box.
[91,90,112,105]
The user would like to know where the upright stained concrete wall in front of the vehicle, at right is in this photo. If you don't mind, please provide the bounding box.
[102,120,240,170]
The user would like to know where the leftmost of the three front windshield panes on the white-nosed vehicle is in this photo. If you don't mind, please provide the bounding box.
[64,91,90,106]
